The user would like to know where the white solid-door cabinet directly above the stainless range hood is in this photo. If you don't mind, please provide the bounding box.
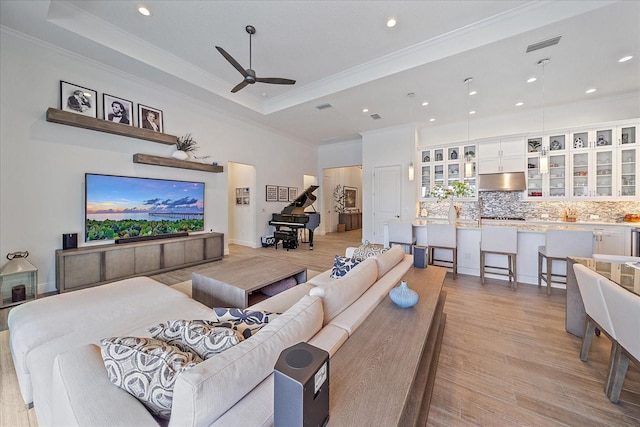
[478,137,524,173]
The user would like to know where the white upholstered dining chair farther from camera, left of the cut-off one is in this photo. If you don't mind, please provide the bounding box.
[573,264,618,392]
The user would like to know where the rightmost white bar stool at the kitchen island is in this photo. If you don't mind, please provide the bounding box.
[538,230,593,295]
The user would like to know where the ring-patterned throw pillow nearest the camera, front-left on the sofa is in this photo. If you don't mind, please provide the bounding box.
[100,337,202,420]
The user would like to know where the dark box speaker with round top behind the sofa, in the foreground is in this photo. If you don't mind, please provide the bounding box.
[273,342,329,427]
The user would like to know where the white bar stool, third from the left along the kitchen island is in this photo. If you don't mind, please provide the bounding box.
[480,226,518,289]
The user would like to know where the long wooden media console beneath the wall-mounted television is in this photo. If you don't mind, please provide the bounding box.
[56,232,224,293]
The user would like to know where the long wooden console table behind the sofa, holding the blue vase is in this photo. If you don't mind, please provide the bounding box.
[328,266,446,427]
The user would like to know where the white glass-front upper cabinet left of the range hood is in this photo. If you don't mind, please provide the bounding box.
[420,144,477,200]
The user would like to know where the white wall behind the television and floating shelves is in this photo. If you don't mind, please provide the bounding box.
[0,30,318,291]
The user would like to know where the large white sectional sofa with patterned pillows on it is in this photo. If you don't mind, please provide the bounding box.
[9,246,412,426]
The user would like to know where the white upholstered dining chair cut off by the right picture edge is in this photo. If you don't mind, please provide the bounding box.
[600,277,640,403]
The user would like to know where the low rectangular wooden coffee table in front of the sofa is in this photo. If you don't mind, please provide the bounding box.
[191,257,307,308]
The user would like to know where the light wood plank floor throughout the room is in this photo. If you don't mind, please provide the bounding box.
[0,231,640,427]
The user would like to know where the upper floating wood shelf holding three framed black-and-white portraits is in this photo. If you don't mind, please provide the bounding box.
[47,108,177,145]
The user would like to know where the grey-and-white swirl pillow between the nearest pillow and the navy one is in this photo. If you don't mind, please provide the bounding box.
[149,320,243,360]
